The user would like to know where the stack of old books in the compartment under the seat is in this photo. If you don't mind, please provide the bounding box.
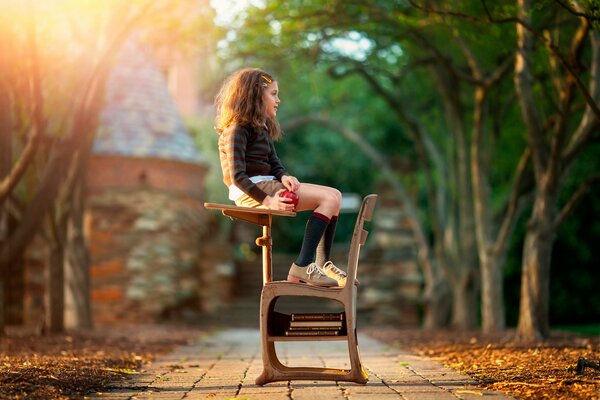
[285,313,344,336]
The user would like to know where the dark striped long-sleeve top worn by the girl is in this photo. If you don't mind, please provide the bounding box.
[219,125,287,203]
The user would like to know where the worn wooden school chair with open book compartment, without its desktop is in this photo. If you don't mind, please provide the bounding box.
[256,194,377,385]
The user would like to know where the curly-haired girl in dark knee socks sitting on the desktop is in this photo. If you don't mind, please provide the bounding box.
[215,68,346,287]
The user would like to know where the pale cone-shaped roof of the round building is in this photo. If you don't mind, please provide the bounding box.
[93,39,206,163]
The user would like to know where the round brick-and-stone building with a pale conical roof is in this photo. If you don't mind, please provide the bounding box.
[86,40,208,324]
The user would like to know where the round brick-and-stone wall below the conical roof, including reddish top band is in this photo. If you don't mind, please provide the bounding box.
[86,156,217,324]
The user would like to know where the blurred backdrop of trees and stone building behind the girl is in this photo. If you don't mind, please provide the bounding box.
[0,0,600,339]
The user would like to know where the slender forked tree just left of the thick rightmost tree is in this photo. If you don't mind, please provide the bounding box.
[400,2,529,332]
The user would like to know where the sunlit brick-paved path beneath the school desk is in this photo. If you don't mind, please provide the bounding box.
[90,329,511,400]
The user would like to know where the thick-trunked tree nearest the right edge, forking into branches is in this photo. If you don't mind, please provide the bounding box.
[514,0,600,340]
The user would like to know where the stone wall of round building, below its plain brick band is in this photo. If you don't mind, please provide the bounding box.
[87,189,209,323]
